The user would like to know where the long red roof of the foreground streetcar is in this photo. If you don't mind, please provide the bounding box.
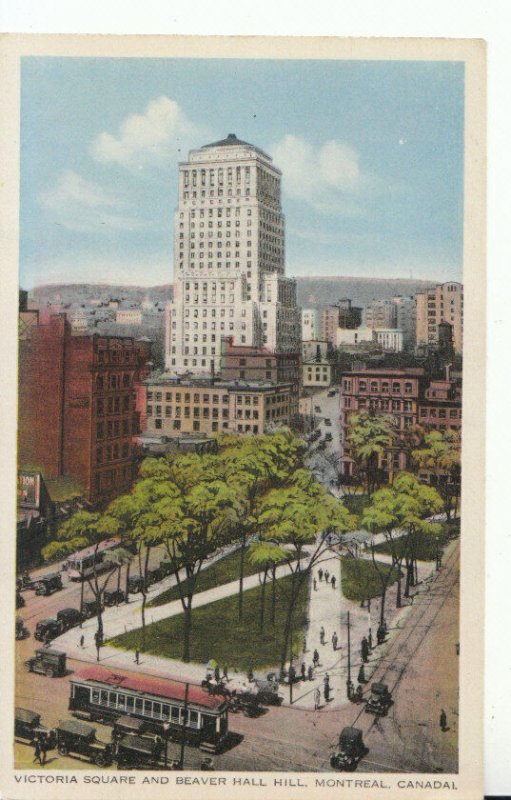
[71,665,225,710]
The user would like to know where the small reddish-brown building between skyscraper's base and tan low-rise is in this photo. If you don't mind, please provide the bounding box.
[220,336,300,417]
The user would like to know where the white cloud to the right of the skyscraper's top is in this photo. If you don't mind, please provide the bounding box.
[269,134,377,216]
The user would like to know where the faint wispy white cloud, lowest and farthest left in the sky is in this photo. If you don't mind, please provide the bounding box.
[38,170,147,233]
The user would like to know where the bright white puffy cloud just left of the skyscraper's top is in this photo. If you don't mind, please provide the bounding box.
[91,96,203,170]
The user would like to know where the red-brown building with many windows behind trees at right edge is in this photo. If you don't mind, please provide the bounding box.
[339,367,461,475]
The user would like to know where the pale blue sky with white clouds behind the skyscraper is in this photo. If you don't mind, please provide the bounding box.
[20,57,464,289]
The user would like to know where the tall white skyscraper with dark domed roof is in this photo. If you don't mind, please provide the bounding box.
[165,133,300,374]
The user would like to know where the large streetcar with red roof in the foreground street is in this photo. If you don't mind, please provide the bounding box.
[69,665,228,753]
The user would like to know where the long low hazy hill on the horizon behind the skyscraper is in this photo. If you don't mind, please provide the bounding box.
[29,276,435,308]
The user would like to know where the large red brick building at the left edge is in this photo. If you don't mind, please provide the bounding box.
[18,314,150,504]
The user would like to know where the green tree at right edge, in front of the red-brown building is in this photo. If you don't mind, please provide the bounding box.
[412,430,461,521]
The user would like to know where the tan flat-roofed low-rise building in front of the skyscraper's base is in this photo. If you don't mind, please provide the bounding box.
[144,373,293,436]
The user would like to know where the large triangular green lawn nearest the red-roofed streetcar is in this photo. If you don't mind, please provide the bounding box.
[108,576,308,671]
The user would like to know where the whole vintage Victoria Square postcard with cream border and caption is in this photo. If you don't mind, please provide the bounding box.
[0,35,486,800]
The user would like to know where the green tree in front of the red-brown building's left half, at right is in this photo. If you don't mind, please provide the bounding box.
[348,411,397,497]
